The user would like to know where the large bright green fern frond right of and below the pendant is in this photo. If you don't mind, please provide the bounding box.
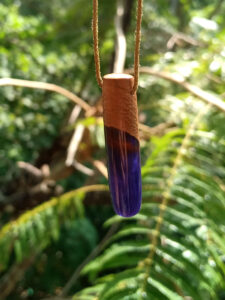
[75,106,225,300]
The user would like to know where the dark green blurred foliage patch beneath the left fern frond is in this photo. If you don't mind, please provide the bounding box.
[22,218,98,299]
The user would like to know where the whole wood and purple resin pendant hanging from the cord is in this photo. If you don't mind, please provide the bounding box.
[103,74,142,217]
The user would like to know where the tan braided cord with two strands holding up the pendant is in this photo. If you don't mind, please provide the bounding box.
[92,0,143,94]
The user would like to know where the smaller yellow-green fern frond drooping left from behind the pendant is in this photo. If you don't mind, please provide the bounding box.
[0,185,108,271]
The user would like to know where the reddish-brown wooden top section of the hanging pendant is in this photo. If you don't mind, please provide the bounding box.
[102,74,139,140]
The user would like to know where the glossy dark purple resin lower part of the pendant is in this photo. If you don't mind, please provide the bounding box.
[105,126,142,217]
